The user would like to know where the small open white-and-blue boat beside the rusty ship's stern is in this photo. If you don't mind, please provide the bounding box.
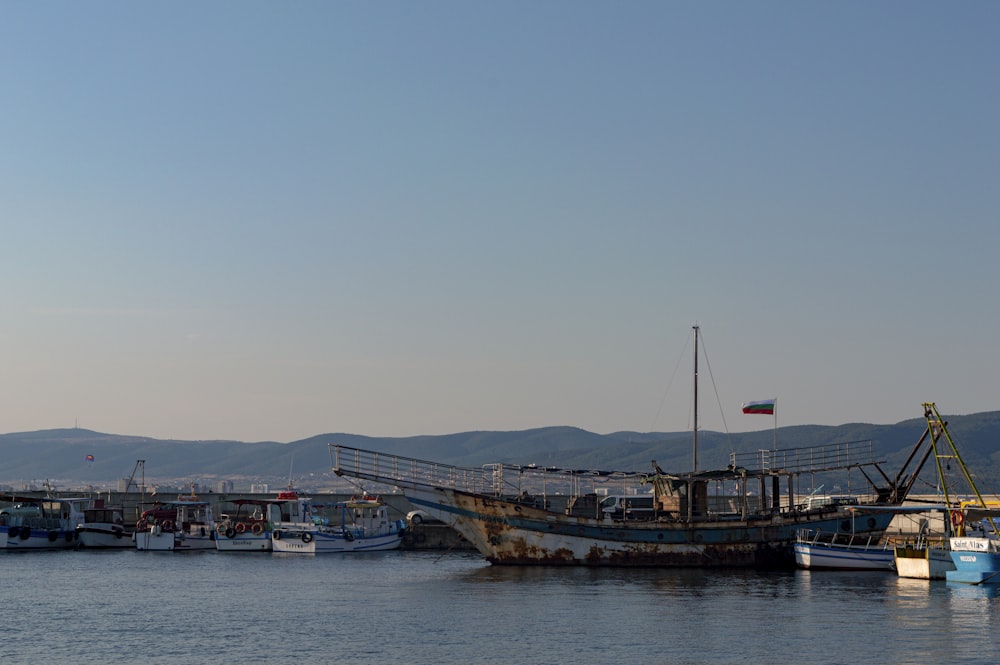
[792,529,894,571]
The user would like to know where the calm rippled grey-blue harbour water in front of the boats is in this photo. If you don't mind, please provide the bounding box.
[0,551,1000,665]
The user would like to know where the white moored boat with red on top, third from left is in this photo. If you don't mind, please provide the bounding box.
[134,494,216,552]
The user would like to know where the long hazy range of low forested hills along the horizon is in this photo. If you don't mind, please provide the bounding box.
[0,411,1000,492]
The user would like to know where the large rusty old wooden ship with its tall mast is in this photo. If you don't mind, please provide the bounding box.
[330,328,929,568]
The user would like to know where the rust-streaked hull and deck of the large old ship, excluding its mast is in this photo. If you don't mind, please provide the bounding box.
[331,445,908,568]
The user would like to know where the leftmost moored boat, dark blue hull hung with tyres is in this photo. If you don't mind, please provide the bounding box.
[0,496,91,550]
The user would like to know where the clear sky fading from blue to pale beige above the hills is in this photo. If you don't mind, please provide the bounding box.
[0,0,1000,442]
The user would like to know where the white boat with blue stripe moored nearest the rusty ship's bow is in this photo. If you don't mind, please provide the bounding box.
[271,496,406,554]
